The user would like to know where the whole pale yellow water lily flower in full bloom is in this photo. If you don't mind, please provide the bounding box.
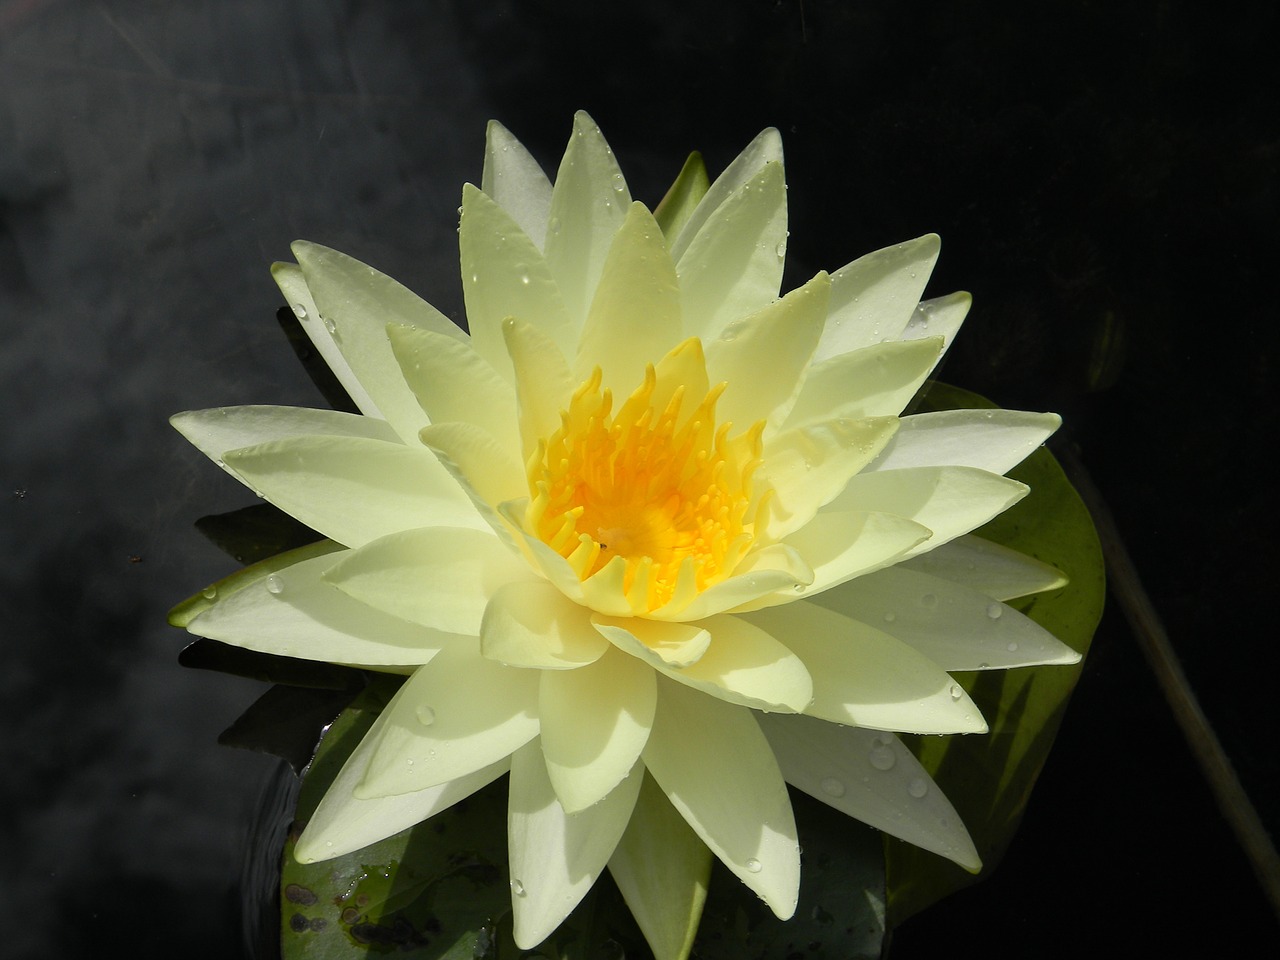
[173,114,1078,957]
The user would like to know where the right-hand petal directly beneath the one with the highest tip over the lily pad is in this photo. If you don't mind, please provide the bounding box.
[829,467,1028,556]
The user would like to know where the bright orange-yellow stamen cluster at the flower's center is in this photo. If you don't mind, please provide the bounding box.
[527,345,764,612]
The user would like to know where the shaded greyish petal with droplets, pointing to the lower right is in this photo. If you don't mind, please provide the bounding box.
[759,716,982,873]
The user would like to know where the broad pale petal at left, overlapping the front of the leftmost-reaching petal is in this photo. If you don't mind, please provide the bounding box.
[224,436,484,547]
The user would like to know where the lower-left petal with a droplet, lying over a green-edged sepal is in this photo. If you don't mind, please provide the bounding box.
[188,550,457,666]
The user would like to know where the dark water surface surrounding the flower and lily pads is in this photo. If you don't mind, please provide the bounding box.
[0,0,1280,960]
